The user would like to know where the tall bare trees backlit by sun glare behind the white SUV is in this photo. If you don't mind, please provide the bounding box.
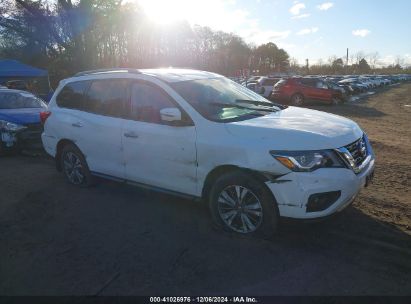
[0,0,289,84]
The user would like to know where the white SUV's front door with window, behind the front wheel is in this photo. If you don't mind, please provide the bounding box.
[123,81,197,195]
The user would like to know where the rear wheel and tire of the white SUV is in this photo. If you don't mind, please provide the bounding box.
[60,144,94,187]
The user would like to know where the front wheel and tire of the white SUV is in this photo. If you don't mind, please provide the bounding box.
[209,170,279,239]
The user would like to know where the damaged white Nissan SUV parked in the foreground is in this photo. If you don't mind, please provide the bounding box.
[42,69,374,235]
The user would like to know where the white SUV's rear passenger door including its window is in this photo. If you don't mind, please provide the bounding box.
[74,78,130,178]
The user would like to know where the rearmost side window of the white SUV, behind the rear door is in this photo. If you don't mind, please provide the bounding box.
[56,81,90,109]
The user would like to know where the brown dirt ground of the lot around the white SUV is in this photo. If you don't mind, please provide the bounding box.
[0,84,411,295]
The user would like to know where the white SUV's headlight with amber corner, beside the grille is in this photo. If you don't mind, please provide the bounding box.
[270,150,344,172]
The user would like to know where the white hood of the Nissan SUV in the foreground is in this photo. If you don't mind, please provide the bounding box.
[226,107,363,150]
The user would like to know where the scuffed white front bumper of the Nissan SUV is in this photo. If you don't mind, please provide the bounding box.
[266,157,375,219]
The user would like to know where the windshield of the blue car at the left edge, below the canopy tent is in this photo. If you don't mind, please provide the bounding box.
[0,92,46,109]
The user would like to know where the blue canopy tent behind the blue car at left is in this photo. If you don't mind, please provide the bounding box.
[0,59,50,101]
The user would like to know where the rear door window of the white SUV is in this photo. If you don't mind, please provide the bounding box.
[84,79,128,117]
